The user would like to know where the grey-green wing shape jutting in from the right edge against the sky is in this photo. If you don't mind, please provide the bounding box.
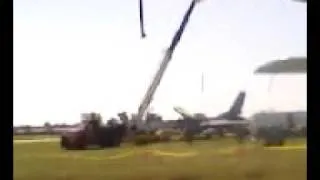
[255,57,307,74]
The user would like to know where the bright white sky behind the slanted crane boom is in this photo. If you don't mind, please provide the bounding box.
[14,0,306,125]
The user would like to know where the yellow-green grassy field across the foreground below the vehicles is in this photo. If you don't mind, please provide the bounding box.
[14,140,306,180]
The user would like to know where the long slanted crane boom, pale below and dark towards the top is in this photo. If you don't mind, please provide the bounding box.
[136,0,199,124]
